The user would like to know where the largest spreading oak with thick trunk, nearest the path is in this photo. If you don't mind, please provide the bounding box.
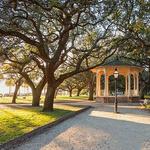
[0,0,122,111]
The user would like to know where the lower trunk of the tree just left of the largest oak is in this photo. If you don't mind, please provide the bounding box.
[32,88,42,107]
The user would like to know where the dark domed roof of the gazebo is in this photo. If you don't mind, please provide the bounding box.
[101,57,142,67]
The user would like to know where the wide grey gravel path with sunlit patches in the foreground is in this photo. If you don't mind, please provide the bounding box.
[12,104,150,150]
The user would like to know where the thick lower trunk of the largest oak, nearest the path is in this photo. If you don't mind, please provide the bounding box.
[43,83,56,111]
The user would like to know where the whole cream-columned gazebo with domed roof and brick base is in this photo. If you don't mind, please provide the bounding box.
[92,57,143,102]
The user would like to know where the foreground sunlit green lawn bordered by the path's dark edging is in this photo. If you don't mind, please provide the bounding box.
[0,105,80,143]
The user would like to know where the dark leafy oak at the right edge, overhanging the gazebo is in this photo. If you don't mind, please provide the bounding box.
[111,0,150,97]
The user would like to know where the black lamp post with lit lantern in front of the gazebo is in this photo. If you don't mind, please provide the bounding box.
[114,68,119,113]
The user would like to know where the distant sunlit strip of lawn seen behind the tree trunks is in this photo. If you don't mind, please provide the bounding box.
[0,95,88,103]
